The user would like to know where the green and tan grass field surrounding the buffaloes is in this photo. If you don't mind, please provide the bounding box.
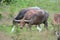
[0,0,60,40]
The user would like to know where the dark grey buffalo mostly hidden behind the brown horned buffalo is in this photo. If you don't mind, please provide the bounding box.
[12,7,40,32]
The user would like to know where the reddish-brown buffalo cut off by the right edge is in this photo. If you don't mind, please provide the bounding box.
[52,13,60,32]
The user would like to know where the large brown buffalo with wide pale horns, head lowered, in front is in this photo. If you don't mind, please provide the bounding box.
[11,8,49,31]
